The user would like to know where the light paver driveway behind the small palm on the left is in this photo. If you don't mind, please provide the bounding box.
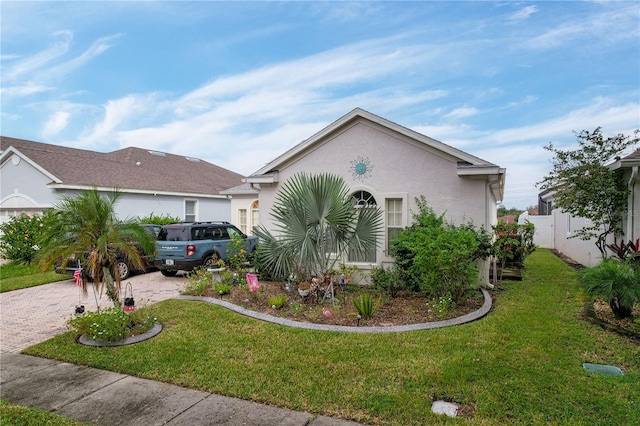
[0,272,186,353]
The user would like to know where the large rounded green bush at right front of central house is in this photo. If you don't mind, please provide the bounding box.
[392,197,490,303]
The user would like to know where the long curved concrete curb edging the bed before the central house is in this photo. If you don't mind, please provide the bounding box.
[174,288,493,333]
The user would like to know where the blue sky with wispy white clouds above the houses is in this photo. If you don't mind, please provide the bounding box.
[0,1,640,208]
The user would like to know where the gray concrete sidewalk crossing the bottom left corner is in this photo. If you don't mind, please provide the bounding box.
[0,353,358,426]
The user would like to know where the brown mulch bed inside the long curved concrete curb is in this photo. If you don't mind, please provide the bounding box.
[202,281,484,327]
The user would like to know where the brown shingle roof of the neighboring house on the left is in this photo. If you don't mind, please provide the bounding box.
[0,136,243,195]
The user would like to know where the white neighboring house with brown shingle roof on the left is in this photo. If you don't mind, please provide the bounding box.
[0,136,242,225]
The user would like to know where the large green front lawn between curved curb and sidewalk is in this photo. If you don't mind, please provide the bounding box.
[20,250,640,425]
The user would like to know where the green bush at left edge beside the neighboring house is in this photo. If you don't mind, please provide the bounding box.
[0,211,51,263]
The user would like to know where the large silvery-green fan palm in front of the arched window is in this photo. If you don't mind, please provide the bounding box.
[256,173,382,280]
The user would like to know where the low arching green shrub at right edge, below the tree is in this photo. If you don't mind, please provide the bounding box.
[580,259,640,318]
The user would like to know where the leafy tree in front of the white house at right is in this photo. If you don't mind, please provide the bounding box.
[538,127,640,258]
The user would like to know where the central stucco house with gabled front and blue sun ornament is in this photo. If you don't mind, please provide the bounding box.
[224,108,505,277]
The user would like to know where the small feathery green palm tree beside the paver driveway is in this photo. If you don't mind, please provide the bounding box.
[38,188,154,308]
